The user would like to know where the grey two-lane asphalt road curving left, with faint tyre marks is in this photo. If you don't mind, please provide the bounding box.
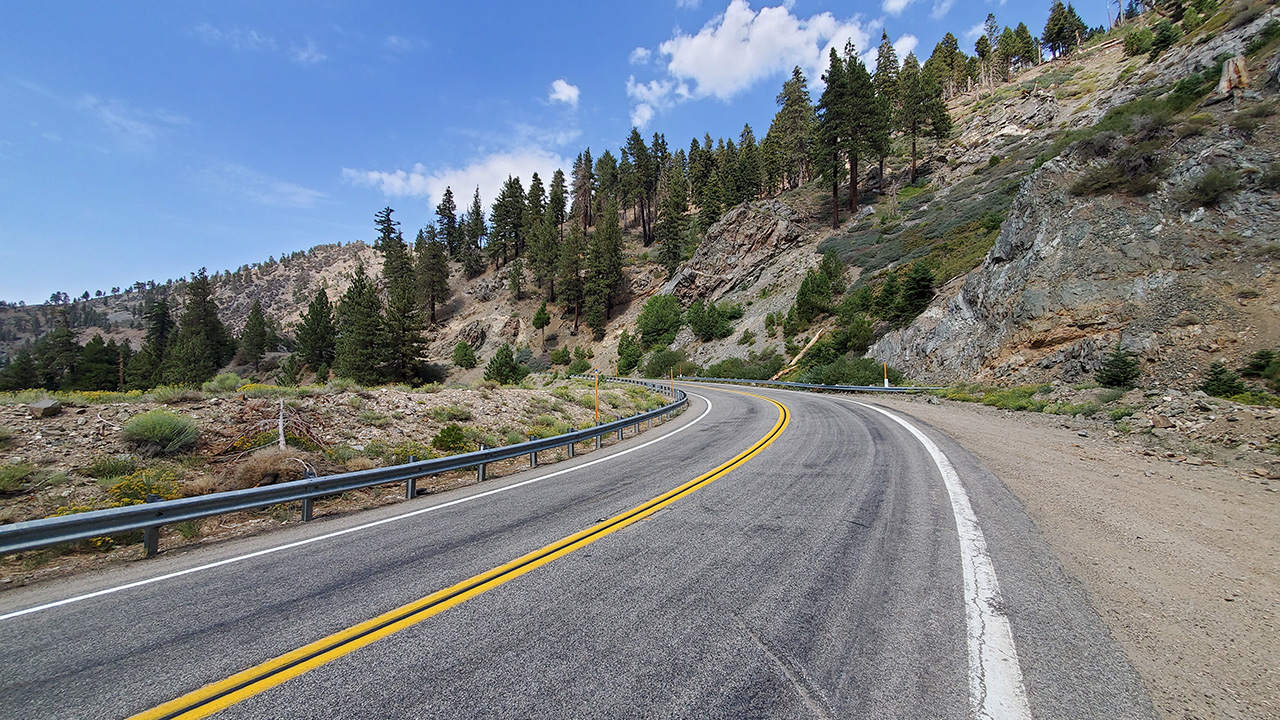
[0,386,1155,720]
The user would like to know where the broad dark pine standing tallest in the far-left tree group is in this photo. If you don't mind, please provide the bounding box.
[161,268,236,384]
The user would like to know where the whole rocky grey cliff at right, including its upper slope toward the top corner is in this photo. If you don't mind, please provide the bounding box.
[872,12,1280,384]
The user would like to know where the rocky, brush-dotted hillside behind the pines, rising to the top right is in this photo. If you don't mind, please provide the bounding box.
[0,4,1280,399]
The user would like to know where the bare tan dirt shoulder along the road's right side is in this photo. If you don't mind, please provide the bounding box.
[878,397,1280,719]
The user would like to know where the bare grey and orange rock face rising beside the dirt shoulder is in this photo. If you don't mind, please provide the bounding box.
[872,140,1280,383]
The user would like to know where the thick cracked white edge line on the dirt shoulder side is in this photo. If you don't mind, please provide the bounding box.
[846,400,1032,720]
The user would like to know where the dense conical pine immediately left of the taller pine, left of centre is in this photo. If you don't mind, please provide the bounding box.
[333,263,387,384]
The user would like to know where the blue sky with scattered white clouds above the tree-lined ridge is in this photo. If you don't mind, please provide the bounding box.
[0,0,1105,302]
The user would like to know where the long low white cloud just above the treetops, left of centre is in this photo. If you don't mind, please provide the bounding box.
[342,147,572,211]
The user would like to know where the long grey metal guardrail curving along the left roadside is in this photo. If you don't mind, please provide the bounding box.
[0,375,689,556]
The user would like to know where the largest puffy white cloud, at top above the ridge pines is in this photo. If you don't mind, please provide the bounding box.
[627,0,874,124]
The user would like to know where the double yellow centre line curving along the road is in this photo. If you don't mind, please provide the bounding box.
[131,391,791,720]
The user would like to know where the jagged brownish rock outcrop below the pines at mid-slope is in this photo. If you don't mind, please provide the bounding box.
[663,200,808,304]
